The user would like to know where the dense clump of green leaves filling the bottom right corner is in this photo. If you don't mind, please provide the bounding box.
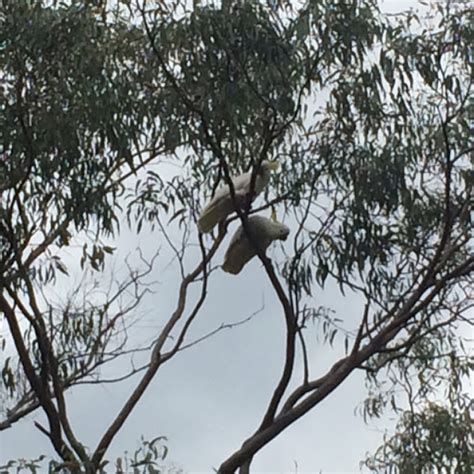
[365,348,474,473]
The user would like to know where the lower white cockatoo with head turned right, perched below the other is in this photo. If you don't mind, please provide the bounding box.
[222,216,290,275]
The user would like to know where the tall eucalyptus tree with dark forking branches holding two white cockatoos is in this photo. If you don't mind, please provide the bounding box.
[0,0,474,473]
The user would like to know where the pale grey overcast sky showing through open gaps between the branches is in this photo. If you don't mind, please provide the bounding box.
[0,0,444,473]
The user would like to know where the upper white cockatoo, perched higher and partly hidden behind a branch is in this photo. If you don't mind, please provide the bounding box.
[198,161,278,234]
